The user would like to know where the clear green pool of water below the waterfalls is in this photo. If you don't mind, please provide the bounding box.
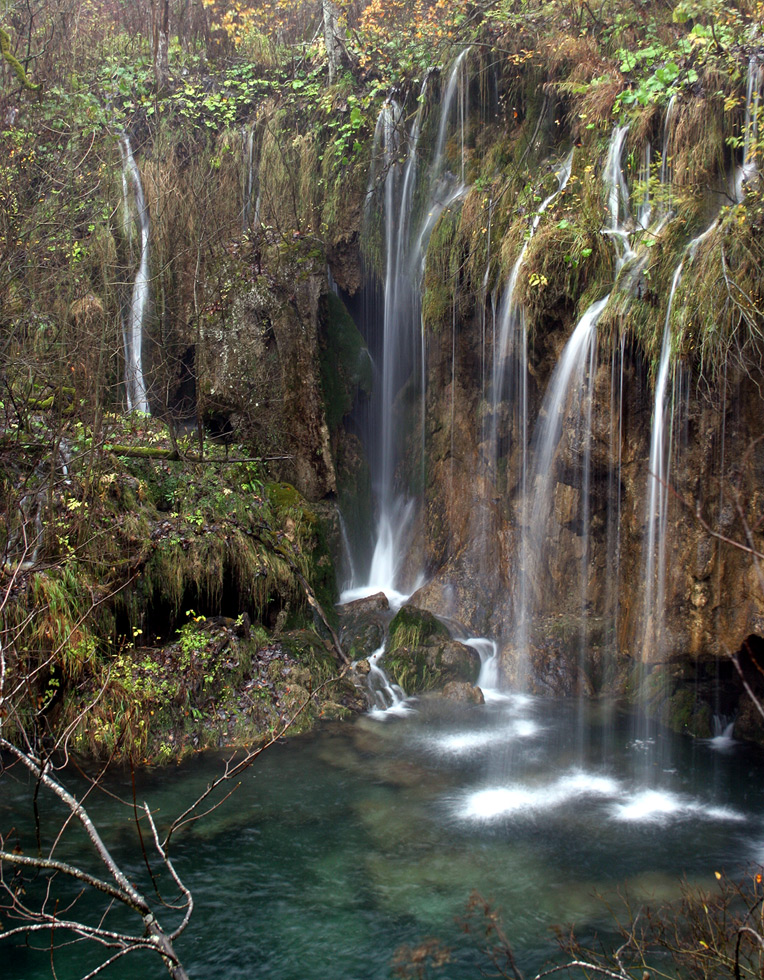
[0,699,764,980]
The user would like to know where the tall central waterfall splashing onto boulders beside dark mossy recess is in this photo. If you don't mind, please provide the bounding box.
[342,49,468,603]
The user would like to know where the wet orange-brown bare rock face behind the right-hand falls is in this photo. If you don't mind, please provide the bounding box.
[400,253,764,732]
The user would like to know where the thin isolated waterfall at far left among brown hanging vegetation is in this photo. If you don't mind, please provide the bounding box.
[119,136,151,415]
